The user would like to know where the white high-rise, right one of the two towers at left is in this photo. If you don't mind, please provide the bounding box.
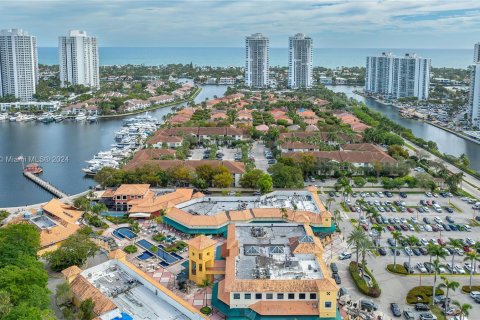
[58,30,100,88]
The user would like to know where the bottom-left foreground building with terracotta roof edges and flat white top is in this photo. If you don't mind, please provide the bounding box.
[62,250,208,320]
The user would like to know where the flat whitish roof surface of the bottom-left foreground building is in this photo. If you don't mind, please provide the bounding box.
[82,260,190,320]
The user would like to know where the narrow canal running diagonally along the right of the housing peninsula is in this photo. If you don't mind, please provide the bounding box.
[329,86,480,171]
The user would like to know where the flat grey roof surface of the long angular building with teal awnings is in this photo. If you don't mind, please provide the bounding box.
[176,190,320,215]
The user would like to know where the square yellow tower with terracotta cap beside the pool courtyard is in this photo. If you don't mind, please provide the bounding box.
[187,235,217,285]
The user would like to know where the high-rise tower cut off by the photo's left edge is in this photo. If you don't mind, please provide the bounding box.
[0,29,38,101]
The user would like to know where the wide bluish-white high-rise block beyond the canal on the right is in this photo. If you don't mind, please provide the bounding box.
[365,53,430,100]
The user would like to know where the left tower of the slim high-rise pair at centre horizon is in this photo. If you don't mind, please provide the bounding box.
[245,33,270,88]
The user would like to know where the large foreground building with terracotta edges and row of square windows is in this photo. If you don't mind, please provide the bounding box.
[212,223,341,319]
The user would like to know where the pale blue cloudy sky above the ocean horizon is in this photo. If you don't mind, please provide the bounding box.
[0,0,480,49]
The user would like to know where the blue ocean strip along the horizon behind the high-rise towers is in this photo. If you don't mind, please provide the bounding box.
[38,47,473,68]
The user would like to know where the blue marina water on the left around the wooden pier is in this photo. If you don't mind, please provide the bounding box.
[0,86,227,208]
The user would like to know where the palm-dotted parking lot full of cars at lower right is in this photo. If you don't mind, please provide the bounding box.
[321,192,480,320]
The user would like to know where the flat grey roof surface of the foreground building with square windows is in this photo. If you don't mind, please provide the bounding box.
[236,223,323,280]
